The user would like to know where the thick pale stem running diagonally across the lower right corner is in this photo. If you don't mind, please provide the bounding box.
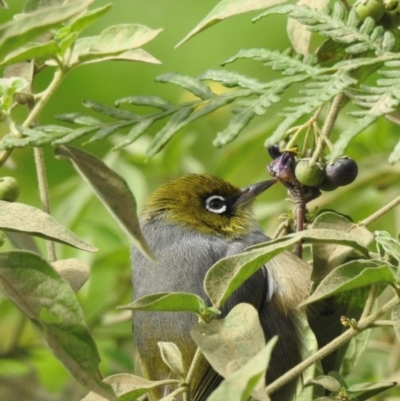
[265,296,400,395]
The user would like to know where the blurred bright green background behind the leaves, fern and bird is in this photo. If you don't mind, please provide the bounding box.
[0,0,400,401]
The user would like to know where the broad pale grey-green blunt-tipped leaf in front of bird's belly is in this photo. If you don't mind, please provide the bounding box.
[190,303,265,378]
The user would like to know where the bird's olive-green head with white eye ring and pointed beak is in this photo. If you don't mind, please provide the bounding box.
[143,174,275,240]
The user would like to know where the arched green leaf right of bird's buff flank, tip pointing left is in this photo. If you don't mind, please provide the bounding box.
[301,259,395,306]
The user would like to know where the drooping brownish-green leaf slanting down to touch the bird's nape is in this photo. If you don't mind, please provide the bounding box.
[54,146,155,260]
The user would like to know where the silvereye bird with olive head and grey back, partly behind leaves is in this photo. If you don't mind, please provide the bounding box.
[132,174,310,401]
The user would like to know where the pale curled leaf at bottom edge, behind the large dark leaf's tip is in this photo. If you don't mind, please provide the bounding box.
[81,373,179,401]
